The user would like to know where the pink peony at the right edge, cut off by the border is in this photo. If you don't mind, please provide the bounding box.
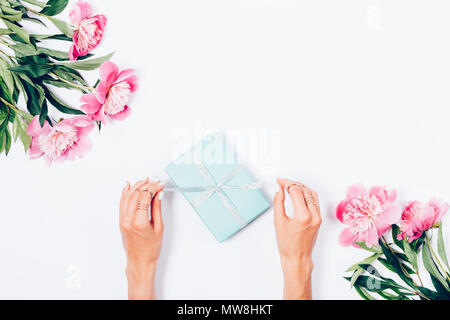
[397,198,449,242]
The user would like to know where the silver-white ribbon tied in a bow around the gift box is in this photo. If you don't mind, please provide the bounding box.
[165,158,262,229]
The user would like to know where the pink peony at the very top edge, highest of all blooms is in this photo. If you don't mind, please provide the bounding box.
[69,1,106,61]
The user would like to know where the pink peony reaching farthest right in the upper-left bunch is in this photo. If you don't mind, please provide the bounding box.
[81,61,138,122]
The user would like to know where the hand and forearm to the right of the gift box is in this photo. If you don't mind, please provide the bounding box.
[274,179,322,300]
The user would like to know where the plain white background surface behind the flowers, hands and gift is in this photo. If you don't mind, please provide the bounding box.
[0,0,450,299]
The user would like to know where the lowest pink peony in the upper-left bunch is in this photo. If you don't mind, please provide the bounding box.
[28,116,95,165]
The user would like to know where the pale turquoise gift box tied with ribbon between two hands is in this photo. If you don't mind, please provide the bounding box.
[166,133,270,242]
